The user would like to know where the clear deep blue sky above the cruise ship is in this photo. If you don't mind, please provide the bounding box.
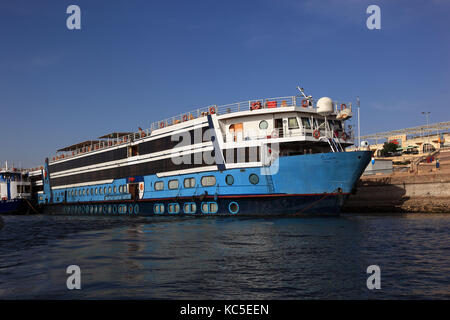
[0,0,450,167]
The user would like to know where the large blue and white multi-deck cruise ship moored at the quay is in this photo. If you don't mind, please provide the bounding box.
[30,88,371,216]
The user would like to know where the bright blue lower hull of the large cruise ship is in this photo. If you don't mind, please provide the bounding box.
[38,151,371,215]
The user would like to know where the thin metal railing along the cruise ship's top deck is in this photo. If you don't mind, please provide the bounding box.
[50,96,351,162]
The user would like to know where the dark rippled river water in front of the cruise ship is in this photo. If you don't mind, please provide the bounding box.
[0,214,450,299]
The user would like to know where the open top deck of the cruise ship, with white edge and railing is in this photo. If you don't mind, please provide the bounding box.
[49,96,351,163]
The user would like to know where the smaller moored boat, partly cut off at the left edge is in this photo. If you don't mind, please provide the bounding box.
[0,164,31,214]
